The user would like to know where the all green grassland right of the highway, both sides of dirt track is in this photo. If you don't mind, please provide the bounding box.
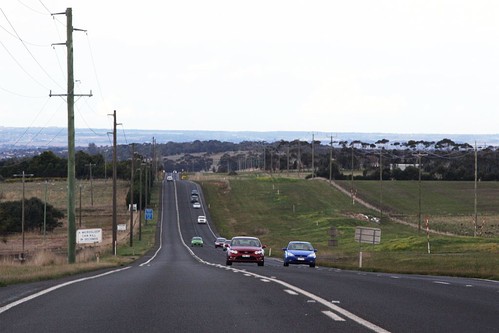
[198,176,499,279]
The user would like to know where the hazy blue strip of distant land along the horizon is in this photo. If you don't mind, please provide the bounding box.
[0,126,499,159]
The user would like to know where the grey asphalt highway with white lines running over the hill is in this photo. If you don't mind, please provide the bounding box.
[0,179,499,332]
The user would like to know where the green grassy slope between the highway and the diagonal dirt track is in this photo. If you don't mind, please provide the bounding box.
[196,174,499,278]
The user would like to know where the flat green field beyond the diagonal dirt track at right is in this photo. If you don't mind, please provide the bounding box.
[337,181,499,237]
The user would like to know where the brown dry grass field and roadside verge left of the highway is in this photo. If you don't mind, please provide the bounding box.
[0,180,150,286]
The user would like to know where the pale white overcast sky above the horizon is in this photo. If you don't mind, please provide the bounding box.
[0,0,499,134]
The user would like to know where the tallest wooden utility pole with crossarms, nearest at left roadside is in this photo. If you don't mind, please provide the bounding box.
[49,8,92,264]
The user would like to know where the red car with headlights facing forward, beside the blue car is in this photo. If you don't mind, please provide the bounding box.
[225,236,265,266]
